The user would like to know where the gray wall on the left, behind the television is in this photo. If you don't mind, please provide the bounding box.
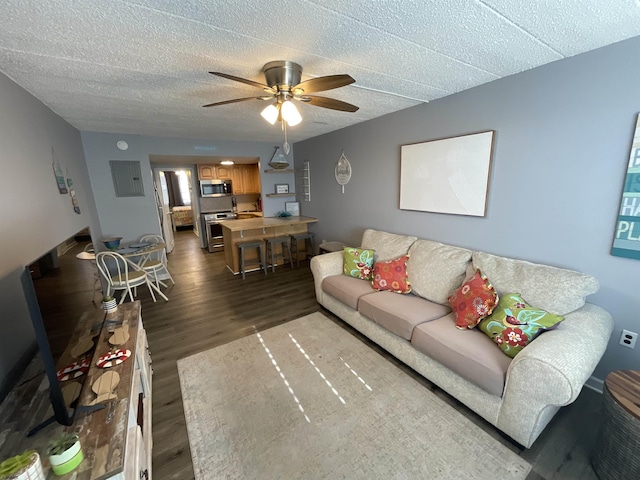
[0,74,97,391]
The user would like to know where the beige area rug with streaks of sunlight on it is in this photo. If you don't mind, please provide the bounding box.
[178,312,531,480]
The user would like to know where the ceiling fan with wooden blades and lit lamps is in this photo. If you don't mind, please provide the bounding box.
[203,60,358,126]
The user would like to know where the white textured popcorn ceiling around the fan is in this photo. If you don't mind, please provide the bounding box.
[0,0,640,142]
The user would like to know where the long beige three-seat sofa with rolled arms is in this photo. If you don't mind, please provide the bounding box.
[311,230,613,448]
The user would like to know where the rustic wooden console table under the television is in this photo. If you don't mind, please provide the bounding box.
[0,301,152,480]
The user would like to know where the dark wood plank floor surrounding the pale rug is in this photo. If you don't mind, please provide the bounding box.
[131,231,601,480]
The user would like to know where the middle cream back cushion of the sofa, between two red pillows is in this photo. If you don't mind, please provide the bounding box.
[408,240,471,305]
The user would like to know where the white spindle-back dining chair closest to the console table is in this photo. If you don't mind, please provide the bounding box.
[96,252,156,303]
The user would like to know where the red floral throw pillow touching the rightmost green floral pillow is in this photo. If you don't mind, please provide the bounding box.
[449,270,498,330]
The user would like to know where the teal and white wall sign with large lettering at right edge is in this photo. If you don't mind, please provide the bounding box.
[611,114,640,260]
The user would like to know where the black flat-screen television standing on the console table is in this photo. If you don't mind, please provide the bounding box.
[21,229,100,435]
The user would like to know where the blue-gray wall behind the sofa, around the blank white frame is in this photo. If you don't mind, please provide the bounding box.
[295,37,640,379]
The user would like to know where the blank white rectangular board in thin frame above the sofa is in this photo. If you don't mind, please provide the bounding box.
[400,130,494,217]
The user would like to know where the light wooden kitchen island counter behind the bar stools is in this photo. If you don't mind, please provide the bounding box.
[220,217,318,274]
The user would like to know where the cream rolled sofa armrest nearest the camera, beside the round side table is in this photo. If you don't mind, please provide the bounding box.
[498,303,613,446]
